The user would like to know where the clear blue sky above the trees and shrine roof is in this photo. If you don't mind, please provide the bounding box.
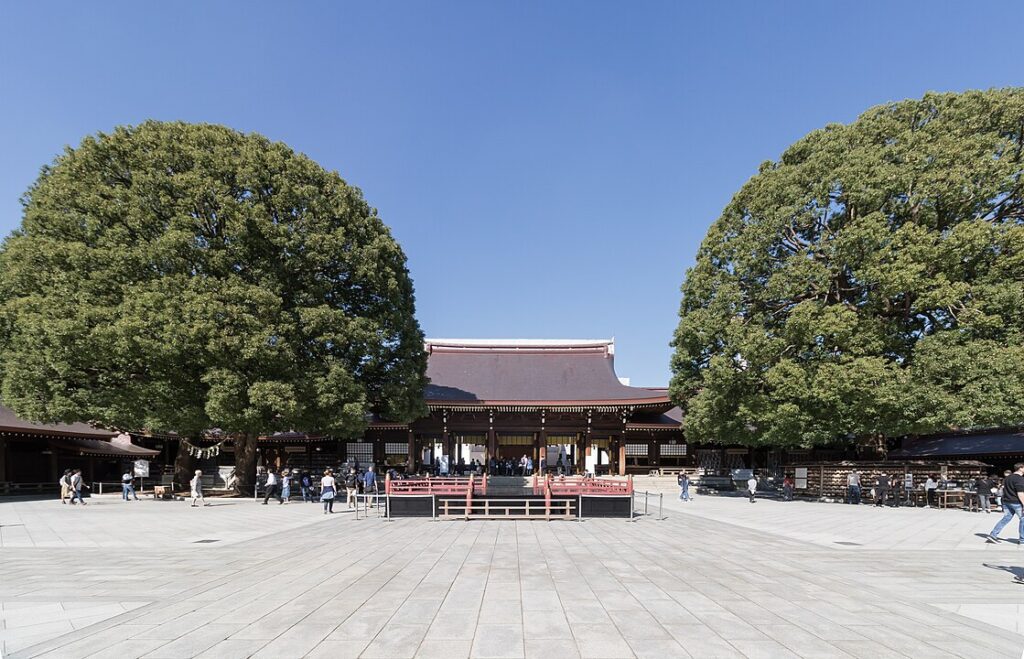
[0,0,1024,386]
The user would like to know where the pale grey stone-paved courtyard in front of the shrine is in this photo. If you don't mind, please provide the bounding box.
[0,496,1024,659]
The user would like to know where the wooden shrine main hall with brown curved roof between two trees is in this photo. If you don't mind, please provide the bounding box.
[360,339,687,475]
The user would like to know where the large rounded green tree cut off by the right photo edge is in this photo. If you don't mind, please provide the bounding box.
[671,89,1024,446]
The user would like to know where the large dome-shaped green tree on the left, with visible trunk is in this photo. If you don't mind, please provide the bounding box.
[0,122,426,484]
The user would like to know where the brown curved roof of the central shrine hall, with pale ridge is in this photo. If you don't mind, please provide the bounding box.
[426,340,669,405]
